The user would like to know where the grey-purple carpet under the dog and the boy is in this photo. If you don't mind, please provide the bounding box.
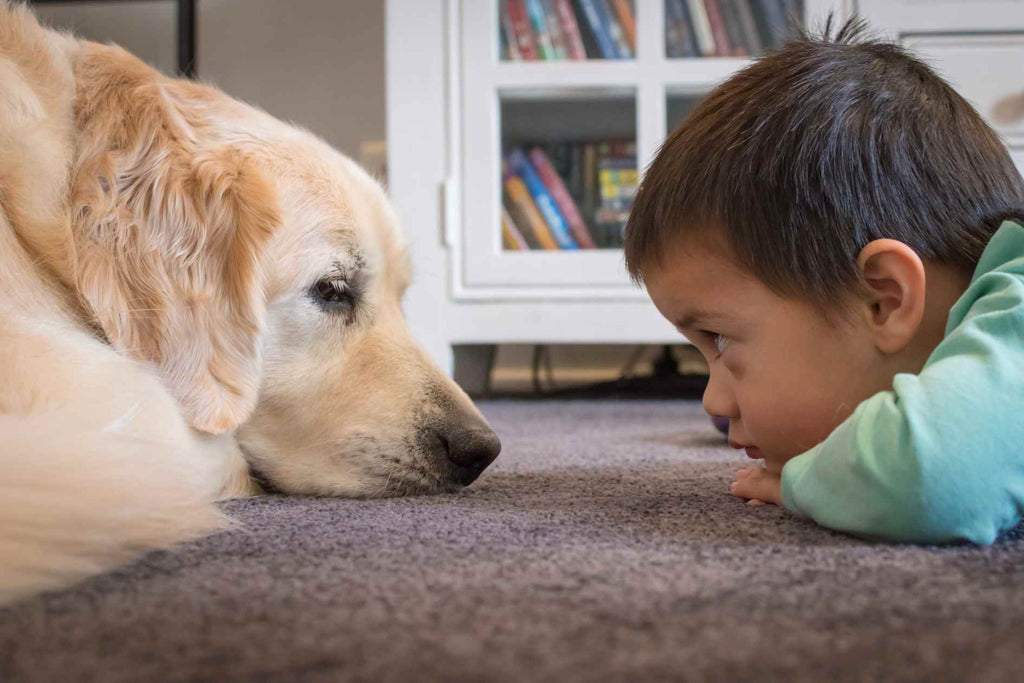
[0,402,1024,682]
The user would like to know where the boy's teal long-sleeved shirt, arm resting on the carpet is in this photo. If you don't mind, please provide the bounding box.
[782,222,1024,544]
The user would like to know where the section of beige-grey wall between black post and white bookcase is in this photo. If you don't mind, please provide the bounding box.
[197,0,385,158]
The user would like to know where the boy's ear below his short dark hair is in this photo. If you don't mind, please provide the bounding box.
[857,240,926,353]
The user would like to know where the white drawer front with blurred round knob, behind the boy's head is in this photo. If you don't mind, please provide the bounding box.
[903,34,1024,148]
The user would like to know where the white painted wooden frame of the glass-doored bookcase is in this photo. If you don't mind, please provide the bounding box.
[386,0,888,370]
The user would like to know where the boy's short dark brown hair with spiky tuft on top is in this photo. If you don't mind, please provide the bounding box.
[625,17,1024,309]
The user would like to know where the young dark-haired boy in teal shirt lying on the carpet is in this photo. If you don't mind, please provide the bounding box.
[626,18,1024,544]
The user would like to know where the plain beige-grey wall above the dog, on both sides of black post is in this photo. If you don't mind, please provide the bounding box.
[36,0,385,159]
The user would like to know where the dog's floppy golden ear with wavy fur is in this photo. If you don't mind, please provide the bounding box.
[71,63,279,432]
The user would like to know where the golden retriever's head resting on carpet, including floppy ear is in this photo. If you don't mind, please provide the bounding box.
[62,43,500,497]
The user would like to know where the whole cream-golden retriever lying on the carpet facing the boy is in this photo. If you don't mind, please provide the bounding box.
[0,3,501,602]
